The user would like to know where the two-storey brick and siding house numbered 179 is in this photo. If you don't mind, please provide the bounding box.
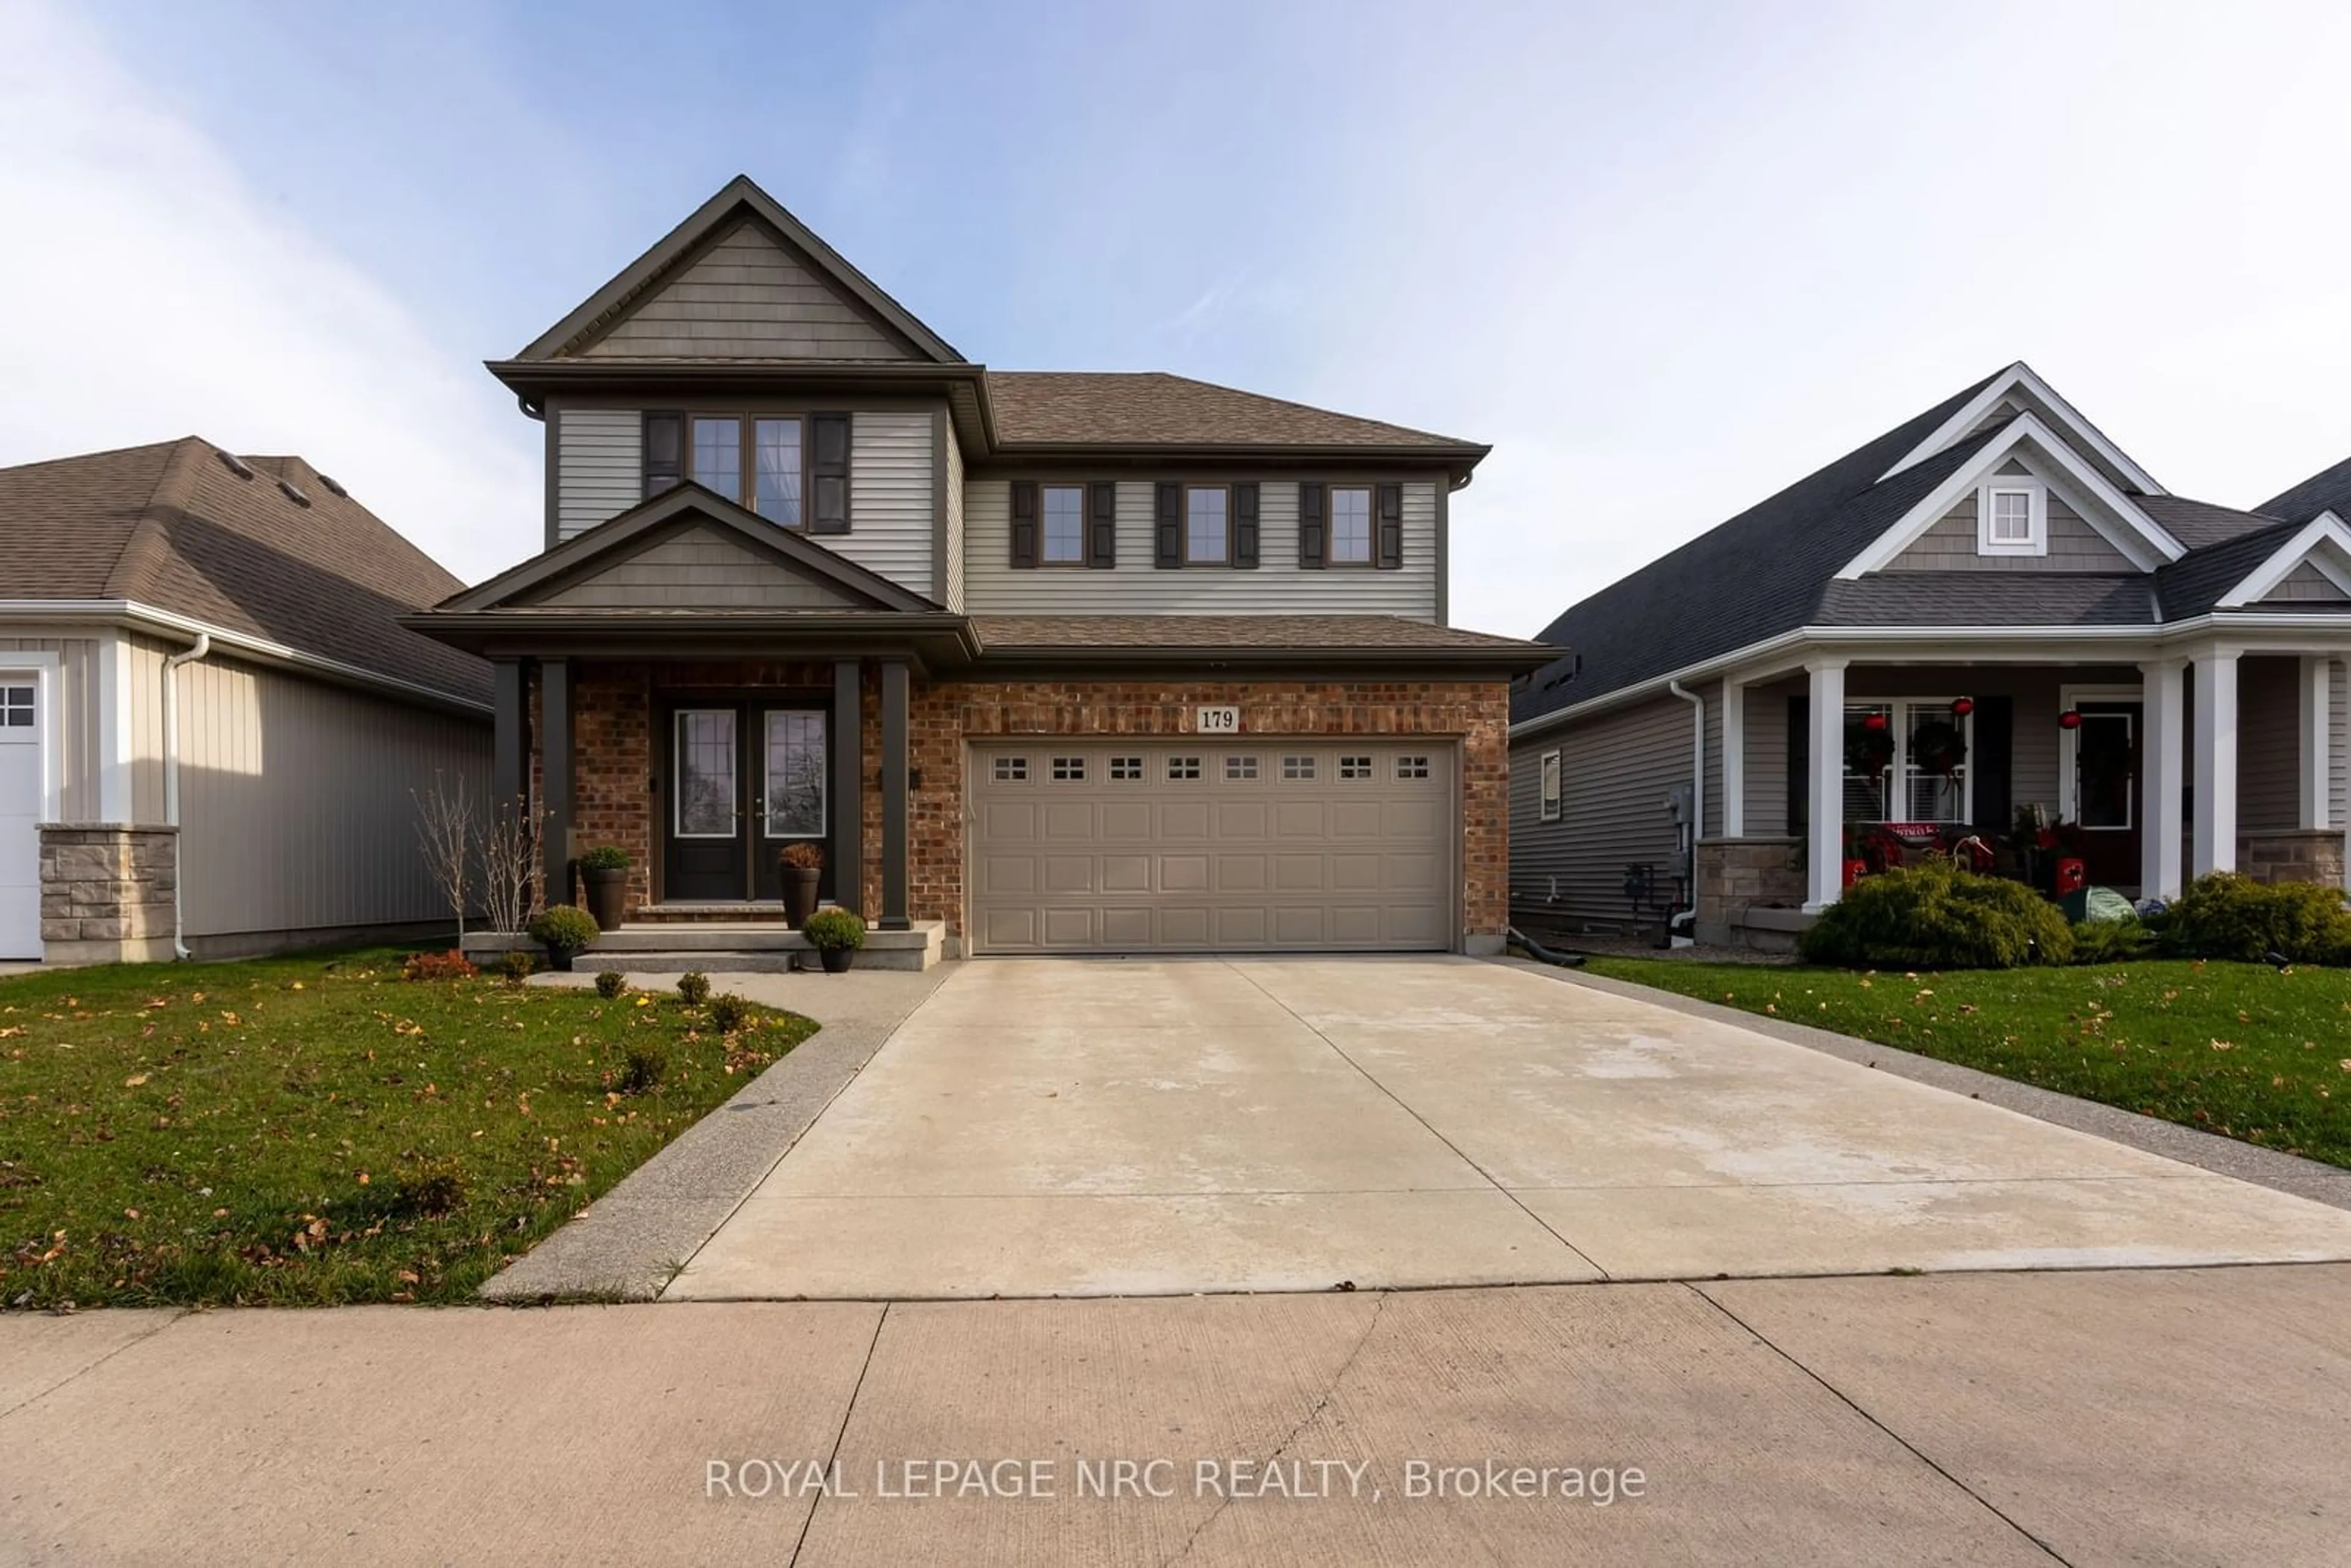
[407,179,1550,961]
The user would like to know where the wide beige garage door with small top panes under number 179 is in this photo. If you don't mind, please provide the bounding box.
[969,736,1460,952]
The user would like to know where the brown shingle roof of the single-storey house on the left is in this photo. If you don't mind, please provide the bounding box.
[0,435,489,703]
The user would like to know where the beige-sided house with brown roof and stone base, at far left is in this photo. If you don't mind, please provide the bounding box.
[0,437,489,964]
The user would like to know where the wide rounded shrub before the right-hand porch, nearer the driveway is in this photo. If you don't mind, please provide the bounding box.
[1801,860,2074,969]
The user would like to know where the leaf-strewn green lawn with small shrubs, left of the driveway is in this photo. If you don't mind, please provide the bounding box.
[0,950,816,1307]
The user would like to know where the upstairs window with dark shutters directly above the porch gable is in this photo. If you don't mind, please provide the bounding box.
[644,414,849,534]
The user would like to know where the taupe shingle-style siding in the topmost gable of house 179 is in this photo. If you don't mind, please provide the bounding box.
[580,221,915,359]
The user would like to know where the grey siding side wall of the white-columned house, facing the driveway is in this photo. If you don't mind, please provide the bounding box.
[1509,696,1690,926]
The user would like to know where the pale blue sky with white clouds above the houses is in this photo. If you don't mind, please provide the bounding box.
[0,0,2351,632]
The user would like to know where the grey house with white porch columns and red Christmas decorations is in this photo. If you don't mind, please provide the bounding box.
[1512,364,2351,945]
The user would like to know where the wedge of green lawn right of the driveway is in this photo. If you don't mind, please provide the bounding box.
[1589,957,2351,1166]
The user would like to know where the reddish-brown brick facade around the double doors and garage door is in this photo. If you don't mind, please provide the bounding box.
[531,661,1509,940]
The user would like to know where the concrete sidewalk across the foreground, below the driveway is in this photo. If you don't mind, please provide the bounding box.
[0,1265,2351,1568]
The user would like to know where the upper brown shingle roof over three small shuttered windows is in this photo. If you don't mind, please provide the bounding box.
[988,369,1477,451]
